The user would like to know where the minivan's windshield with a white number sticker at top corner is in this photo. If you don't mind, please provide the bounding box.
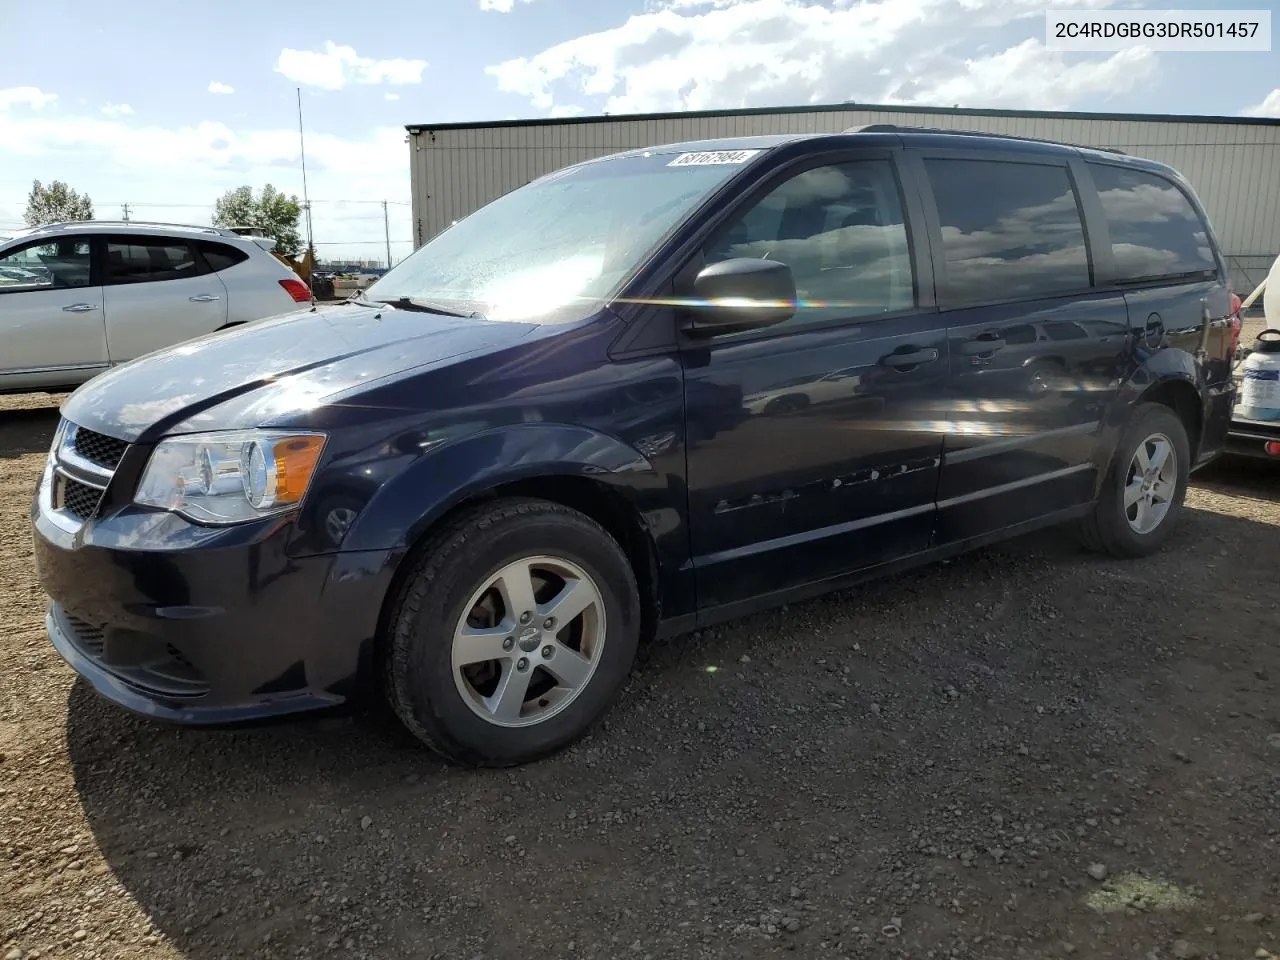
[365,150,760,323]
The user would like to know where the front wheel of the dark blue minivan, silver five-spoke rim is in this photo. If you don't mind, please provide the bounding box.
[384,499,640,767]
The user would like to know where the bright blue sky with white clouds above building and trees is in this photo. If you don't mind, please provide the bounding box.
[0,0,1280,260]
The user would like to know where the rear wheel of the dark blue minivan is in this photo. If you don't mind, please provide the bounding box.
[1079,403,1190,557]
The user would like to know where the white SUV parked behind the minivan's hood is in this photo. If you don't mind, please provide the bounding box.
[0,220,312,393]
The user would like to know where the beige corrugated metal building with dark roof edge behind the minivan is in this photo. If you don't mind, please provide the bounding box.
[407,104,1280,296]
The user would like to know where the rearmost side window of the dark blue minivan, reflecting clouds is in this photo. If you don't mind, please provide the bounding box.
[1088,164,1217,282]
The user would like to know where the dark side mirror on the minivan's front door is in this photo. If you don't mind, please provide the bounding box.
[685,257,796,337]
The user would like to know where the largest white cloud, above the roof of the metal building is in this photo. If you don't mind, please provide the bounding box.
[486,0,1156,114]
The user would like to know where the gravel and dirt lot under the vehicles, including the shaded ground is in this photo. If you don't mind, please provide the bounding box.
[0,398,1280,960]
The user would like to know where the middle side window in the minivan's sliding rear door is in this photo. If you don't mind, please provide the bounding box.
[924,159,1089,306]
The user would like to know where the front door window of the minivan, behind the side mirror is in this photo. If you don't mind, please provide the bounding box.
[705,160,915,326]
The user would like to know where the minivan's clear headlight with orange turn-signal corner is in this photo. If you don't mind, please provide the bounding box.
[133,430,325,524]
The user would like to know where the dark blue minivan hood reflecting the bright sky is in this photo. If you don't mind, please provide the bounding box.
[63,305,538,443]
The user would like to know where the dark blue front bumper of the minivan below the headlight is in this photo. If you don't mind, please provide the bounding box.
[33,511,393,724]
